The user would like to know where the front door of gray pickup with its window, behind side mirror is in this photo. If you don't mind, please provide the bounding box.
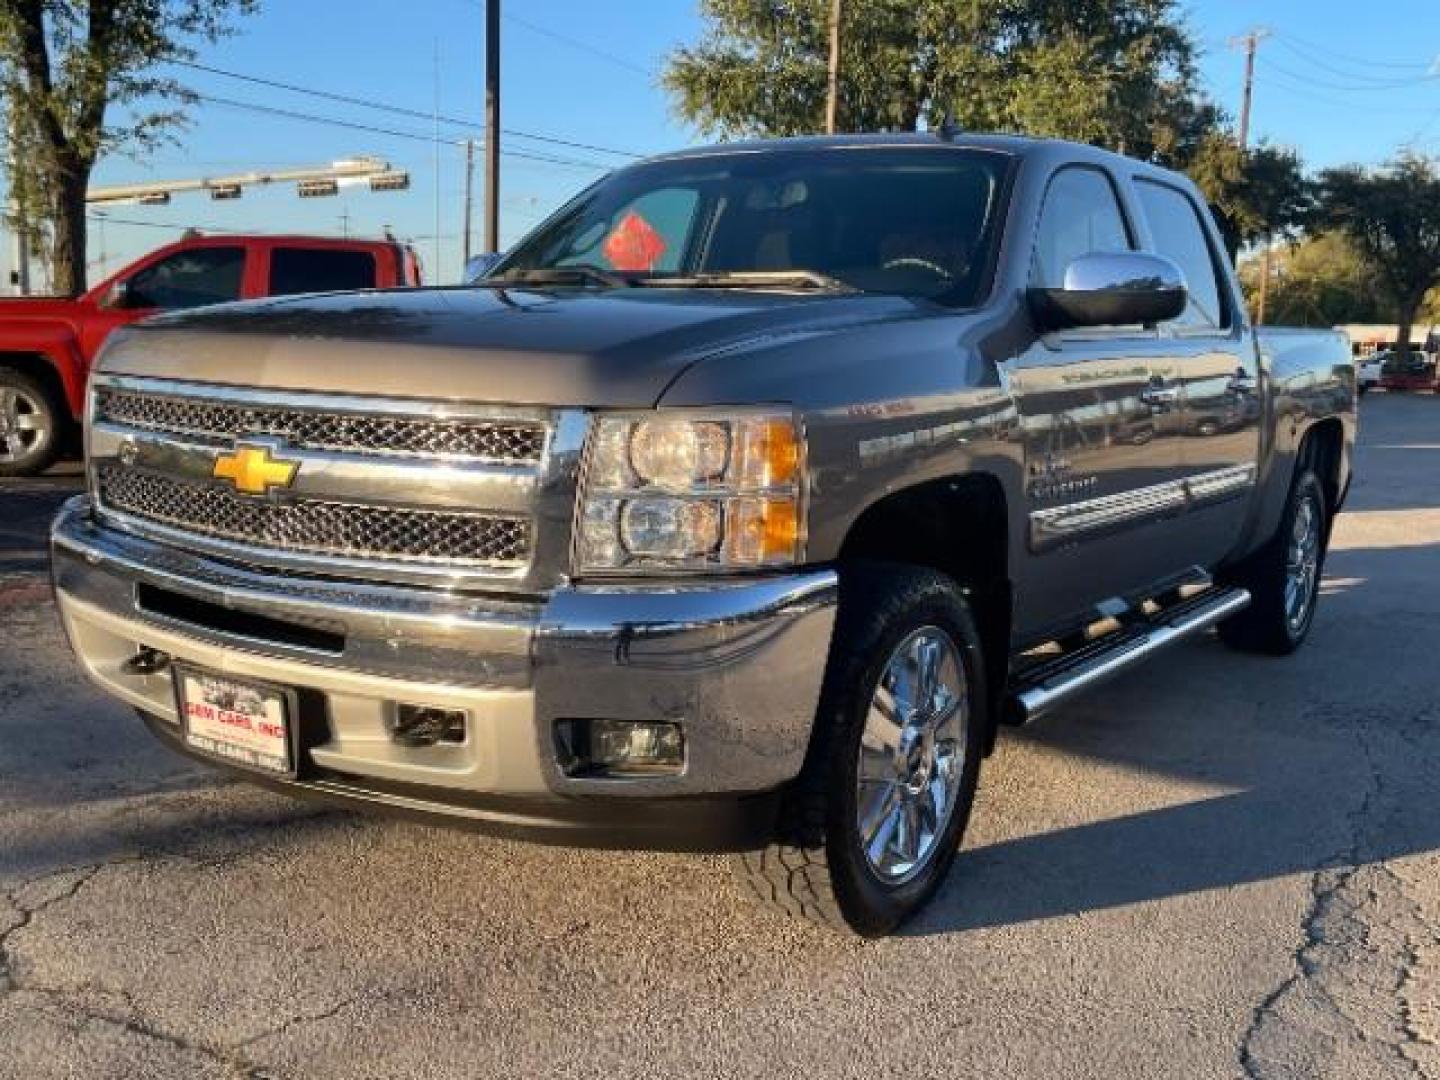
[1007,166,1184,631]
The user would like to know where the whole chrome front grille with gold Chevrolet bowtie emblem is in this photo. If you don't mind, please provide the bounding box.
[86,373,589,595]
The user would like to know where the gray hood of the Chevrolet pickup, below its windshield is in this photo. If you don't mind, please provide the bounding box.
[101,288,919,408]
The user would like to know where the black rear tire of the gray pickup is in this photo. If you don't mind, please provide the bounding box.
[1220,461,1329,657]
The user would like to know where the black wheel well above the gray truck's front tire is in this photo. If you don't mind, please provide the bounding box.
[840,474,1012,744]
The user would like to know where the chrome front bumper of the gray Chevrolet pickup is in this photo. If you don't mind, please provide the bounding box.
[52,497,837,847]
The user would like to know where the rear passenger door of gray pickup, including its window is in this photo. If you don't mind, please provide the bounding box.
[1132,176,1261,567]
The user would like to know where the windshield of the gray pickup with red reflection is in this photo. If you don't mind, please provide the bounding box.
[491,147,1009,305]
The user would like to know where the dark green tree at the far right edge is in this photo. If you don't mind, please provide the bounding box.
[1313,153,1440,361]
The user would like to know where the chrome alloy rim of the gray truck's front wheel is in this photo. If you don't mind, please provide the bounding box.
[855,626,969,886]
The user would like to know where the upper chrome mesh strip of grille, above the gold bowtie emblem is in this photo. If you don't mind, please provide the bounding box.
[95,387,546,464]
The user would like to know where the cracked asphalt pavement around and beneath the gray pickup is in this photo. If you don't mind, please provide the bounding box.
[0,395,1440,1080]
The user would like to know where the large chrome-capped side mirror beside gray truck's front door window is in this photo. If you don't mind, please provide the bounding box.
[1028,251,1187,330]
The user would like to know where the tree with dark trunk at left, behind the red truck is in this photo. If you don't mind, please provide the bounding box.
[0,0,258,294]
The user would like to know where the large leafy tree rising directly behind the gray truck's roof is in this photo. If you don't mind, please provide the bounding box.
[664,0,1214,157]
